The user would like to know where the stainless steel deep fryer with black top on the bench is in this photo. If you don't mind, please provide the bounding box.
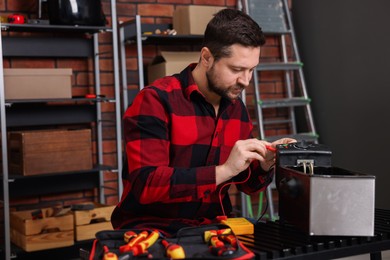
[276,142,375,236]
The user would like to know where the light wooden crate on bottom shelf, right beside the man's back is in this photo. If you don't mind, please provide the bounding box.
[73,203,115,241]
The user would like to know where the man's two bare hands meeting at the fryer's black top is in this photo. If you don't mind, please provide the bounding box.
[216,138,296,185]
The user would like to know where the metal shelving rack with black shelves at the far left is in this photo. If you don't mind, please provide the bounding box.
[0,0,122,260]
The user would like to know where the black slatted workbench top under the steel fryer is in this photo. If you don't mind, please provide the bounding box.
[239,209,390,260]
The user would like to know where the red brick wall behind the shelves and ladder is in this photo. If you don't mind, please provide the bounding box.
[0,0,288,218]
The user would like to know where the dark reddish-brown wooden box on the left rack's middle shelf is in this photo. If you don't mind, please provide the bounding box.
[8,129,92,176]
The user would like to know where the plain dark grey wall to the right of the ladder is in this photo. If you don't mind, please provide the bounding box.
[292,0,390,209]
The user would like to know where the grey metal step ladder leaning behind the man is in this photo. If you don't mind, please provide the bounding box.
[237,0,318,220]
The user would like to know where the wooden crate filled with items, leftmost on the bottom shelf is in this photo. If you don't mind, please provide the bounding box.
[10,208,74,252]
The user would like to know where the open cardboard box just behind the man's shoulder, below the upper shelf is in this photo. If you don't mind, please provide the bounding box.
[148,51,200,83]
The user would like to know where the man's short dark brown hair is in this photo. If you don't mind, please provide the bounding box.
[203,8,265,60]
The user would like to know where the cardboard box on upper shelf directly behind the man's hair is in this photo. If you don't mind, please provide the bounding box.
[173,5,226,35]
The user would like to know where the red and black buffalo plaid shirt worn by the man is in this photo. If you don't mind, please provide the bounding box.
[111,64,272,236]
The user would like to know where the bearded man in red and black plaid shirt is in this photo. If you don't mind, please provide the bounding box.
[111,9,295,235]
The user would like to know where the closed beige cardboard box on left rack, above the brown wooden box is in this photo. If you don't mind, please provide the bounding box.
[4,69,72,99]
